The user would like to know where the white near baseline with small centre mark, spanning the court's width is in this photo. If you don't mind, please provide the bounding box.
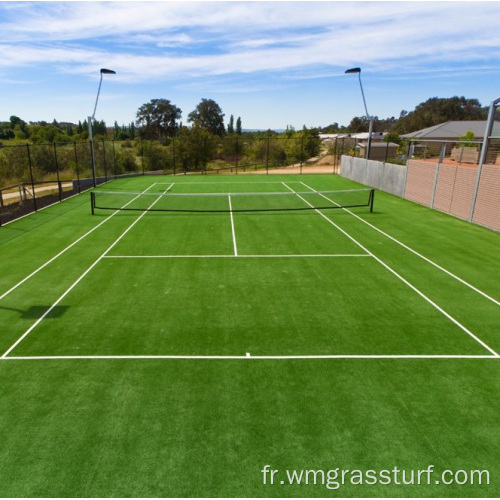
[0,353,499,361]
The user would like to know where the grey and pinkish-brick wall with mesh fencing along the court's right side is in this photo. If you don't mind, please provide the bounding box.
[340,99,500,231]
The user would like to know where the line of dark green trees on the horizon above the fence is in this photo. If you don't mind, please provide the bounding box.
[0,96,488,143]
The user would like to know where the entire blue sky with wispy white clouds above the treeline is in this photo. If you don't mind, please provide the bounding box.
[0,1,500,129]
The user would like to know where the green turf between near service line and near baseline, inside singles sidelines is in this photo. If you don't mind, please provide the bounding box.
[9,258,488,356]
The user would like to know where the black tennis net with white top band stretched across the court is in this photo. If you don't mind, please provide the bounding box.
[90,189,375,214]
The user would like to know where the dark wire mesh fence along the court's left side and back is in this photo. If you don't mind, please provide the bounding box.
[0,133,334,224]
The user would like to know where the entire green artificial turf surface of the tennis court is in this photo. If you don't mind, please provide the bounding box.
[0,175,500,497]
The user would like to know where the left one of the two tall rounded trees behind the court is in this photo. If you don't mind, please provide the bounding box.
[136,99,182,141]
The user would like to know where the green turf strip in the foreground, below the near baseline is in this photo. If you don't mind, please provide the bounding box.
[0,359,500,497]
